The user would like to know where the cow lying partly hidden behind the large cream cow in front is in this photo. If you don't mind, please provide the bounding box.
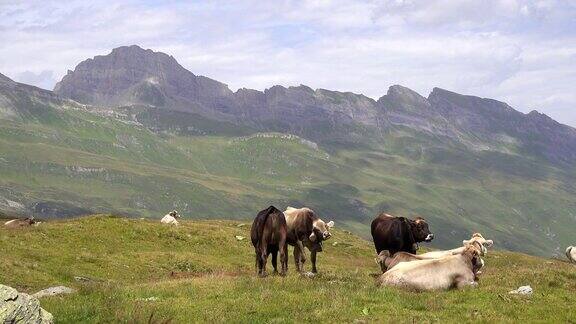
[376,233,494,274]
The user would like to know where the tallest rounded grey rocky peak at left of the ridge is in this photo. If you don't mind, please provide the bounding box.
[54,45,233,114]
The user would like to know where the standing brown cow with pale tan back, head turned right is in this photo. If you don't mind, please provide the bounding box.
[284,207,334,273]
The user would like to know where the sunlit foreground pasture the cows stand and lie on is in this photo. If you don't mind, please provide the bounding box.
[0,216,576,323]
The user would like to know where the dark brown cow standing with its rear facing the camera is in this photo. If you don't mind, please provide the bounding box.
[250,206,288,277]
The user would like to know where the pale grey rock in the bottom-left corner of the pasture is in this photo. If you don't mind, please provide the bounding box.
[0,285,54,324]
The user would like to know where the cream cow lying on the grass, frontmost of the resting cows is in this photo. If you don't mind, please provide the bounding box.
[378,246,483,291]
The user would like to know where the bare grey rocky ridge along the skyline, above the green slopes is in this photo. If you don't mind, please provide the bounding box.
[54,46,576,164]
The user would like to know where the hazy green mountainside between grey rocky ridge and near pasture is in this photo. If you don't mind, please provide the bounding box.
[0,95,576,255]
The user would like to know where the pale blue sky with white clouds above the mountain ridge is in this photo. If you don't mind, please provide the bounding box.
[0,0,576,126]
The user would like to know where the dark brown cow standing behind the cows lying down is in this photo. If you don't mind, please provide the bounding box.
[372,213,434,255]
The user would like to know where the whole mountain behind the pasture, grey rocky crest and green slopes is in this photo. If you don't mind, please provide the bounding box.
[0,46,576,255]
